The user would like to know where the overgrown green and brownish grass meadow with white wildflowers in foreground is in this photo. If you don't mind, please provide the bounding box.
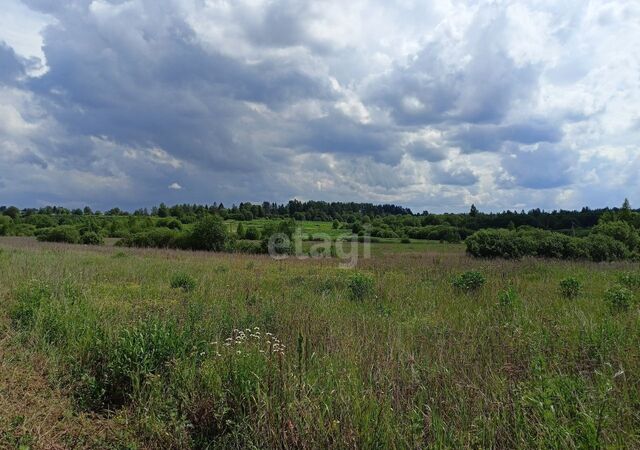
[0,238,640,449]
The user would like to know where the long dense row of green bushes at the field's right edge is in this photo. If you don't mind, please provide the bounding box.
[465,229,632,261]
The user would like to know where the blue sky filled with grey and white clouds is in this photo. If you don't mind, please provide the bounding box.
[0,0,640,212]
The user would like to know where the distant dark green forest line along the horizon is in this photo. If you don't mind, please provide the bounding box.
[0,200,640,232]
